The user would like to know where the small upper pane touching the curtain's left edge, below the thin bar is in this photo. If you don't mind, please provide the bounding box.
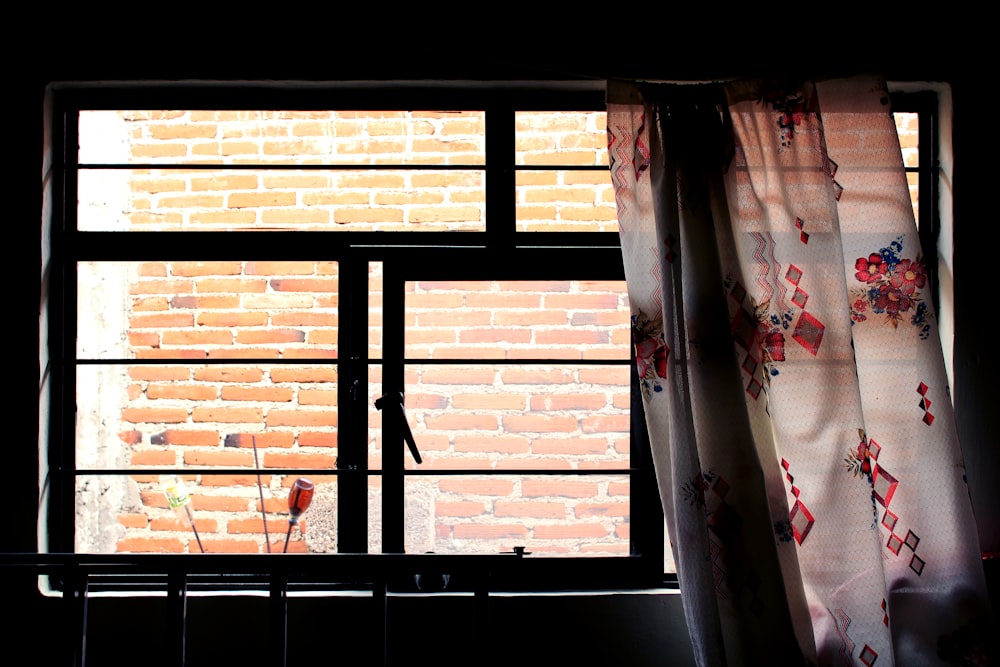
[516,170,618,232]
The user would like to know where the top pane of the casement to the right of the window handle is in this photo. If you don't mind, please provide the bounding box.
[405,280,631,360]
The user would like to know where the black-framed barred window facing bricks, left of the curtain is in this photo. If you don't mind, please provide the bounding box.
[42,85,672,590]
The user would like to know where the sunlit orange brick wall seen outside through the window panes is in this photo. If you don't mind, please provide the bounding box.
[78,111,629,555]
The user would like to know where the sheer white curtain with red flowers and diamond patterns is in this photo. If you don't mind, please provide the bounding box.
[608,76,991,667]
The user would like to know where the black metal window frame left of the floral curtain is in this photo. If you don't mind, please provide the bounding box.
[47,82,676,592]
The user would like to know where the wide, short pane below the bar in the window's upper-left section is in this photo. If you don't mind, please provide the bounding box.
[77,168,486,232]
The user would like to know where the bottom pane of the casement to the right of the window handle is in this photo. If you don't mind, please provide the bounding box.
[405,475,630,557]
